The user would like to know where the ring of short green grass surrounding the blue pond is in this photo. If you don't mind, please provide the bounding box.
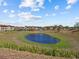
[18,32,70,48]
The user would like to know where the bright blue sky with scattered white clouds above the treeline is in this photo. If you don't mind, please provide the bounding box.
[0,0,79,26]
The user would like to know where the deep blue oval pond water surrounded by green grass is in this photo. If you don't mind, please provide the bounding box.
[26,33,59,44]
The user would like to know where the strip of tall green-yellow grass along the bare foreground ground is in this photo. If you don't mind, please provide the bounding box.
[0,43,79,58]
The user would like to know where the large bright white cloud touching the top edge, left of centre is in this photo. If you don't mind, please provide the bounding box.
[19,0,44,10]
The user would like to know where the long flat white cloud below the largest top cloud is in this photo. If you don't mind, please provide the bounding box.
[18,12,42,20]
